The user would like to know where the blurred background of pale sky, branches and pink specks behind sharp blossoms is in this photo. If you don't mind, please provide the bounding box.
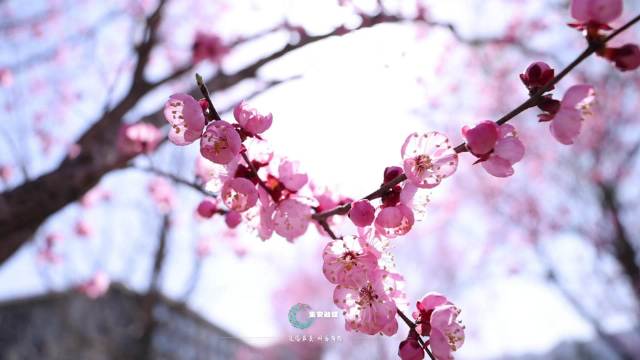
[0,0,640,359]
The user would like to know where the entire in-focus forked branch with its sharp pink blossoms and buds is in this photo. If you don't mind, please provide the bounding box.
[156,0,640,360]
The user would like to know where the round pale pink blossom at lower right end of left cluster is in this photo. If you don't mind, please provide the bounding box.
[272,199,311,241]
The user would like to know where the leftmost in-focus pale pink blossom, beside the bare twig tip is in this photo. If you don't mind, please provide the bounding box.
[164,94,205,145]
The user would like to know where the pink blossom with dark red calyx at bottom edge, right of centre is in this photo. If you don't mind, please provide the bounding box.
[413,292,465,360]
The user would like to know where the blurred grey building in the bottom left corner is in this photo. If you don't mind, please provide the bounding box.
[0,285,262,360]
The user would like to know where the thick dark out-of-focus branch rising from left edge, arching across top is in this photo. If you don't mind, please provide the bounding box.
[0,1,544,263]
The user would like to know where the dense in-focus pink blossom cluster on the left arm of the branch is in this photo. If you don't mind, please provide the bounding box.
[164,89,334,241]
